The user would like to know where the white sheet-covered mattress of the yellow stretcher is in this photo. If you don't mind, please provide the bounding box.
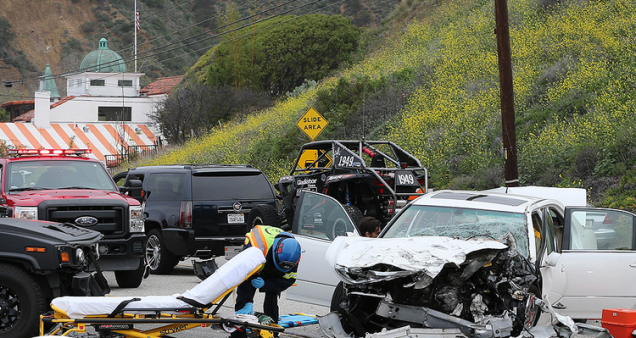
[51,247,265,319]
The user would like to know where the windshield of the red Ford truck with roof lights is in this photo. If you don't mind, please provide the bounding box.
[5,160,117,193]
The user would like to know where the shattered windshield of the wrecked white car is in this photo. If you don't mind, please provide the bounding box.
[382,205,528,257]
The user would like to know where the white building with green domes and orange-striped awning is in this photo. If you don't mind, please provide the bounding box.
[0,38,181,164]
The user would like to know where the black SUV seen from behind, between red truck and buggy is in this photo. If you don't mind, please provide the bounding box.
[114,165,281,274]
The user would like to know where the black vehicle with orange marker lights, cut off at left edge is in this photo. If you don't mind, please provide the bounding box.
[0,218,110,338]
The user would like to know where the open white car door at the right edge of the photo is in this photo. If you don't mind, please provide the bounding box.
[557,207,636,319]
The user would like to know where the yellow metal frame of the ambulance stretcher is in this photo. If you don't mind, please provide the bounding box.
[40,266,285,338]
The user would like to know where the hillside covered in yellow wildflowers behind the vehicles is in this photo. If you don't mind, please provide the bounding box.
[136,0,636,210]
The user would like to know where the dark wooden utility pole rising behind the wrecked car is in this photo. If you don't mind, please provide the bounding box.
[495,0,519,187]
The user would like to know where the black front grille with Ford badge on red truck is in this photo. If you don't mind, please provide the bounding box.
[46,206,124,236]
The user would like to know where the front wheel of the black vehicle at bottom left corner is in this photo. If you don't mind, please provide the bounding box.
[0,264,46,338]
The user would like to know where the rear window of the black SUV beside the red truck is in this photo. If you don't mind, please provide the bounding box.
[192,172,274,201]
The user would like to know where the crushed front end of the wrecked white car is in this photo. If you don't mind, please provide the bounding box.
[321,236,538,338]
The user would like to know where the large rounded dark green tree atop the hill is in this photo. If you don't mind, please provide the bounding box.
[208,14,360,95]
